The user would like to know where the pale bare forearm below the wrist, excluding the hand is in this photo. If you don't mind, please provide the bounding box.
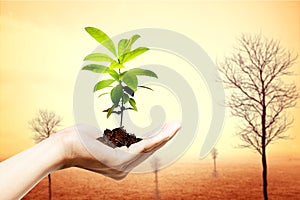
[0,136,64,199]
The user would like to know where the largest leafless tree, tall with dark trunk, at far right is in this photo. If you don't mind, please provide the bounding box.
[219,35,299,199]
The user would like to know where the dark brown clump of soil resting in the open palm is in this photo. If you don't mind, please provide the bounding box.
[97,127,142,148]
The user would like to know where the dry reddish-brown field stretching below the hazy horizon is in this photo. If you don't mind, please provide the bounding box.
[23,159,300,200]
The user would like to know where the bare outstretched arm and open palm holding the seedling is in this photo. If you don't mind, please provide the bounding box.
[0,122,181,199]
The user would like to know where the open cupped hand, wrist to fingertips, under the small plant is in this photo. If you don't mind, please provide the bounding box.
[57,122,181,180]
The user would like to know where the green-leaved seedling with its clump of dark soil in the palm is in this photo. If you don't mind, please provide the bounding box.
[82,27,158,147]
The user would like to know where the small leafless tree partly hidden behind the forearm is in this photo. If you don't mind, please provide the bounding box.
[29,110,62,199]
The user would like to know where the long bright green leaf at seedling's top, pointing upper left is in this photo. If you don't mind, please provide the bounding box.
[85,27,117,56]
